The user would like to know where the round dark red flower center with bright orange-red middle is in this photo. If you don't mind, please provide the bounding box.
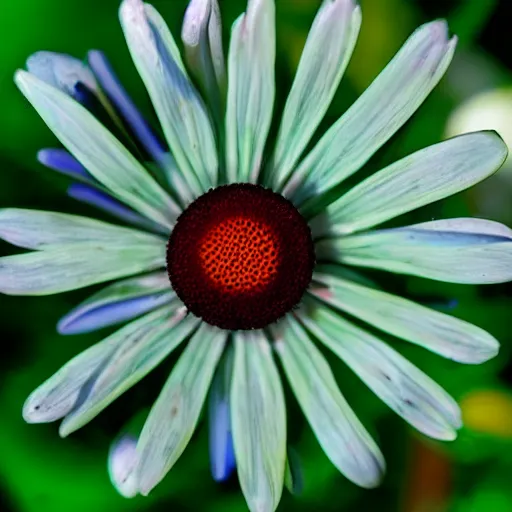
[167,184,315,330]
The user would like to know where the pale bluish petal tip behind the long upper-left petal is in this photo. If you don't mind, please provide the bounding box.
[27,51,99,96]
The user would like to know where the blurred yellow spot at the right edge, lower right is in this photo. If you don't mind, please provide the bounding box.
[460,390,512,438]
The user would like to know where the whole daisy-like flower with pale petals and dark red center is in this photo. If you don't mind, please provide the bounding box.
[4,0,512,511]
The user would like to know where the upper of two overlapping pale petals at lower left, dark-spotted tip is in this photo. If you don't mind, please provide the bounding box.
[23,308,174,423]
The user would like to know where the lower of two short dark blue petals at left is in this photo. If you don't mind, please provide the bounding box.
[67,183,164,231]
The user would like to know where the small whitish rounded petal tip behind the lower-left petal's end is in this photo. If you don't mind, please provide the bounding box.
[108,435,138,498]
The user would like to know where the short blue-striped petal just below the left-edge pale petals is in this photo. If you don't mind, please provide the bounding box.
[57,272,176,334]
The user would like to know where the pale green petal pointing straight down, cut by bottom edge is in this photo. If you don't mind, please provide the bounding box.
[231,331,286,512]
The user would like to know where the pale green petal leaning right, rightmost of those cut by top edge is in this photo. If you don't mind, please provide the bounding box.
[271,0,361,189]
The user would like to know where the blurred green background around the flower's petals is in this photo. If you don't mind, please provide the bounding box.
[0,0,512,512]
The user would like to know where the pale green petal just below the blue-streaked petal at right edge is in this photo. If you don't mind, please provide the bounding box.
[309,266,499,364]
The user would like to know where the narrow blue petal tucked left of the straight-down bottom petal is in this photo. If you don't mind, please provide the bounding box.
[208,347,235,482]
